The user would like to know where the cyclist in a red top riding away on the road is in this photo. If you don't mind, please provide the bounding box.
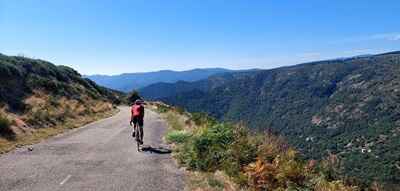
[130,99,144,145]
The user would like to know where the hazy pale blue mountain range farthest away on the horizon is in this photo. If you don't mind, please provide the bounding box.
[85,68,233,92]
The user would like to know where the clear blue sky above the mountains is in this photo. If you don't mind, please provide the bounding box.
[0,0,400,74]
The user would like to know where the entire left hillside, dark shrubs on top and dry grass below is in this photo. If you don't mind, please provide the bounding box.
[0,54,122,152]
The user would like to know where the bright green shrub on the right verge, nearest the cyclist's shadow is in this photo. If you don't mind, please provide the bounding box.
[173,122,260,185]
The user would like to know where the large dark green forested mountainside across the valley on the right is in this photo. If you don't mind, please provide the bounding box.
[158,52,400,187]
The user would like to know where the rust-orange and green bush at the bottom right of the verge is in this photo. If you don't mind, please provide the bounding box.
[245,141,359,191]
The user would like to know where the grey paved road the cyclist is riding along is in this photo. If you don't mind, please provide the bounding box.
[0,107,184,191]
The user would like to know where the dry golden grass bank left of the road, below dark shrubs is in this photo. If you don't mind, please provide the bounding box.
[0,92,118,154]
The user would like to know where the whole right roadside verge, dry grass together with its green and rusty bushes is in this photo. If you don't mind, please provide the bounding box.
[152,104,359,191]
